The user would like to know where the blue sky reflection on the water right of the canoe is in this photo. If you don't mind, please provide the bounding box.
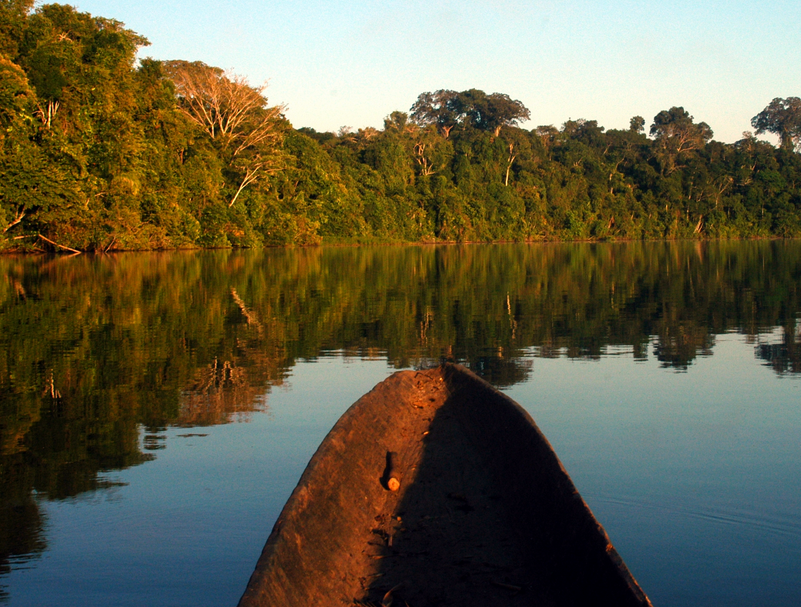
[507,335,801,606]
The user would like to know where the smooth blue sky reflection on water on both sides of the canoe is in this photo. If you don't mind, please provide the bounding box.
[5,342,801,606]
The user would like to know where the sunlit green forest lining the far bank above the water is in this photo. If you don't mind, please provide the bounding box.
[0,0,801,253]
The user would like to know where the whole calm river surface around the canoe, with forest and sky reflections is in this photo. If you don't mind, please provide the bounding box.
[0,242,801,607]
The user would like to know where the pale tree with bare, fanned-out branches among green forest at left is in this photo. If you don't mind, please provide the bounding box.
[165,61,283,207]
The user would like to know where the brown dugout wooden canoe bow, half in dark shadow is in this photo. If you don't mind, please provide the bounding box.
[239,364,651,607]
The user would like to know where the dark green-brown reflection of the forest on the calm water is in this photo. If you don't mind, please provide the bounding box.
[0,241,801,592]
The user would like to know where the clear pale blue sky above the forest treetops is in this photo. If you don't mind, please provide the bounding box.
[72,0,801,143]
